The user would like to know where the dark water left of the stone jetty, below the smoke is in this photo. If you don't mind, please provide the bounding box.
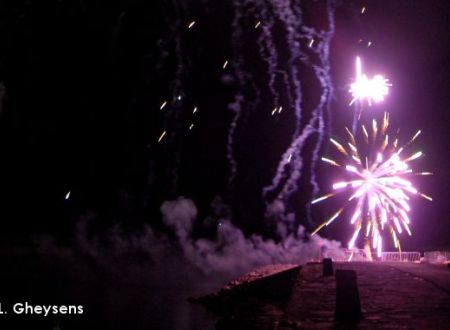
[0,250,221,330]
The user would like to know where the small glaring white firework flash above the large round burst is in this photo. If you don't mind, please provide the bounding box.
[349,56,391,105]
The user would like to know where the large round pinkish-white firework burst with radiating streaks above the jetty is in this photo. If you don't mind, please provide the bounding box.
[311,113,431,256]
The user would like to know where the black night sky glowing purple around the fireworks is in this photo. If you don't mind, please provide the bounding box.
[0,0,450,250]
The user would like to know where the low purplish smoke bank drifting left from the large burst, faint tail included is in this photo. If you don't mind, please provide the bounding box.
[63,197,344,278]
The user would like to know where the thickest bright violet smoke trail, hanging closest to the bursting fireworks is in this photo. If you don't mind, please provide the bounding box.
[264,2,334,224]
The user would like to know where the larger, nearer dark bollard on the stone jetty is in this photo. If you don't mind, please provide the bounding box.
[335,269,362,322]
